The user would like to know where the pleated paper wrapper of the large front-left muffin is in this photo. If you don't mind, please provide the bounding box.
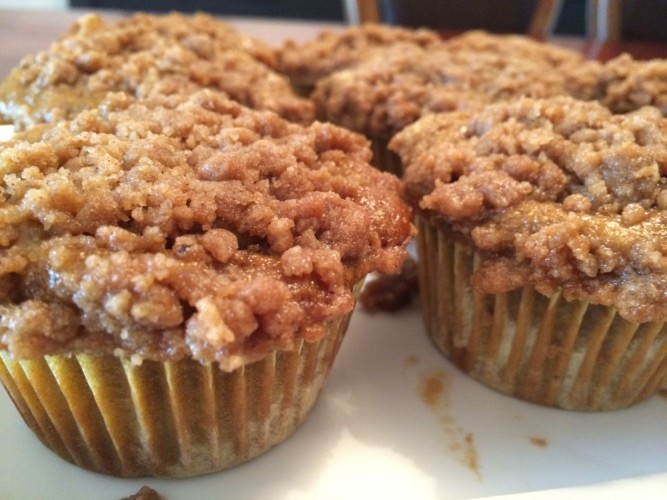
[0,315,350,477]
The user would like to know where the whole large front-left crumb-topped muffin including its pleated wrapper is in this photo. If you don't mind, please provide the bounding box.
[0,90,414,477]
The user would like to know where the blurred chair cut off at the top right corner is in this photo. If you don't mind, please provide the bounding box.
[586,0,667,41]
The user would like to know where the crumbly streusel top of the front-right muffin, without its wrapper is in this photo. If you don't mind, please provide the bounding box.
[390,96,667,322]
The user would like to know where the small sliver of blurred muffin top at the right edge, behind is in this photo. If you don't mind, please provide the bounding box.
[601,54,667,116]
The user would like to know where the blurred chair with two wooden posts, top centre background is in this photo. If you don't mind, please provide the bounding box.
[344,0,562,38]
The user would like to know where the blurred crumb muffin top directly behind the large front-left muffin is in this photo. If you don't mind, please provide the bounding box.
[0,13,314,129]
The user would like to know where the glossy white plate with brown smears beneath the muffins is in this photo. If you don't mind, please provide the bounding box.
[0,296,667,500]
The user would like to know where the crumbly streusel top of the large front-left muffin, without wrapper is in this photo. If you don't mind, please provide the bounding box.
[0,89,413,370]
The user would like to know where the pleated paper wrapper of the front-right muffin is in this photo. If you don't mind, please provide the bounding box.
[417,217,667,411]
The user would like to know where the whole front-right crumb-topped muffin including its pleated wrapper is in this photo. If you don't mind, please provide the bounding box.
[390,96,667,411]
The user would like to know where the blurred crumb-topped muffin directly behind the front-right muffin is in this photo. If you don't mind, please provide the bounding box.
[313,32,599,175]
